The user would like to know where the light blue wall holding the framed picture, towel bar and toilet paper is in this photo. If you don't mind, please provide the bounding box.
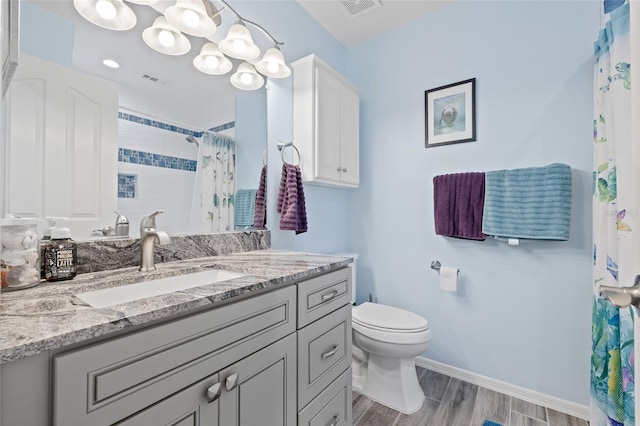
[348,1,598,405]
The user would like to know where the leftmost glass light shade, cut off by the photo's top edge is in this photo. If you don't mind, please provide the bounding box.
[73,0,137,31]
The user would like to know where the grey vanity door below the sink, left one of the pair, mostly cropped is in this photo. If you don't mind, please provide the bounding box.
[116,374,221,426]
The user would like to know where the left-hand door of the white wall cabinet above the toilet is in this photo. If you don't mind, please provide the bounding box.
[314,67,341,182]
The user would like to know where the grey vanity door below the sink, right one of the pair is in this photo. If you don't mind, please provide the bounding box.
[220,333,296,426]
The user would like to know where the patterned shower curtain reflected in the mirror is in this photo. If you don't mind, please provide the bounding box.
[191,132,236,232]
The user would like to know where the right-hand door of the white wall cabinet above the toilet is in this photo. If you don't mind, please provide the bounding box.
[340,86,360,185]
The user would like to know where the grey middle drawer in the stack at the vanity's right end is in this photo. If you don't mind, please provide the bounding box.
[298,305,351,409]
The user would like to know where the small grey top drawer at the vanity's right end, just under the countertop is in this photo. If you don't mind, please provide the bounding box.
[298,268,351,328]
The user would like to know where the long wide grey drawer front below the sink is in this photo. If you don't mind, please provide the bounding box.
[53,286,296,426]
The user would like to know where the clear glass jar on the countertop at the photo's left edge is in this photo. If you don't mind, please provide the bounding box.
[0,218,40,291]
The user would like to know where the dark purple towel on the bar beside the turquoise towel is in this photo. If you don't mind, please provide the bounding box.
[433,172,486,240]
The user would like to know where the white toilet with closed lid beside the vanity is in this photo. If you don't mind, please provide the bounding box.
[340,255,431,414]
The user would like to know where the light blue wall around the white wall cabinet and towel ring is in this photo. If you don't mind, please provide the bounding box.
[233,1,353,253]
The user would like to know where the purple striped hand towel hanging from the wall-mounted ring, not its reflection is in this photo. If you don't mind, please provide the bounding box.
[278,164,307,234]
